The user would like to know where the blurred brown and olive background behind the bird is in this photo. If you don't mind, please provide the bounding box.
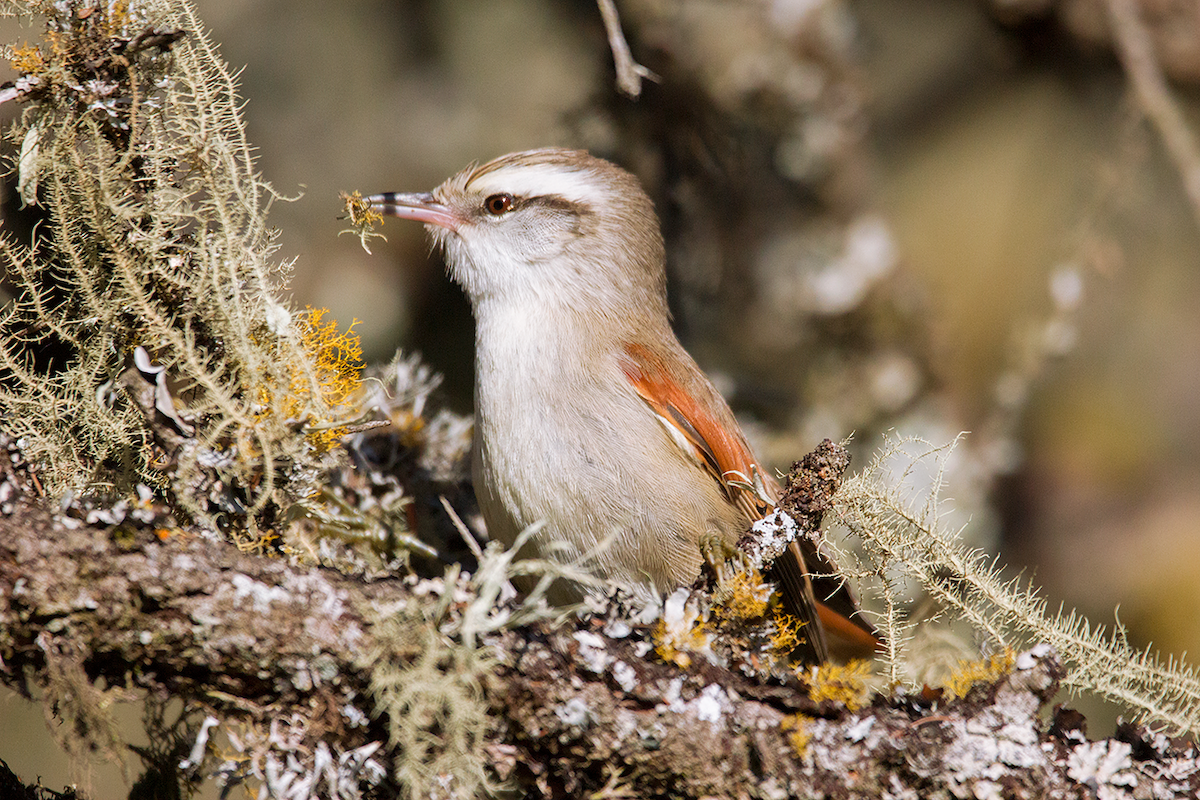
[0,0,1200,796]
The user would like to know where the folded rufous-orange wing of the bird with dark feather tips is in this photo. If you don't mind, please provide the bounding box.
[622,344,825,663]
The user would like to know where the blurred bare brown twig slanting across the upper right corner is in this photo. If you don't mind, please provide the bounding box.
[1106,0,1200,230]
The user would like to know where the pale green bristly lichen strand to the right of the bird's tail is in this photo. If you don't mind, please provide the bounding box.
[834,439,1200,734]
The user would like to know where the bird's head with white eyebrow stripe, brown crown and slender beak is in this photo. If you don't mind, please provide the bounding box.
[367,148,666,314]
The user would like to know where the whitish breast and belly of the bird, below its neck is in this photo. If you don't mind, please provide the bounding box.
[473,311,745,593]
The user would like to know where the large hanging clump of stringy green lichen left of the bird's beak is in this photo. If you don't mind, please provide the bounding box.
[0,0,358,527]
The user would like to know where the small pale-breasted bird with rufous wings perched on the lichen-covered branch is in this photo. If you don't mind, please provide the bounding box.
[365,148,874,663]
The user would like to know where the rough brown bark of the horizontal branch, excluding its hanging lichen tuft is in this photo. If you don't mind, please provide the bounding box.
[0,441,1200,798]
